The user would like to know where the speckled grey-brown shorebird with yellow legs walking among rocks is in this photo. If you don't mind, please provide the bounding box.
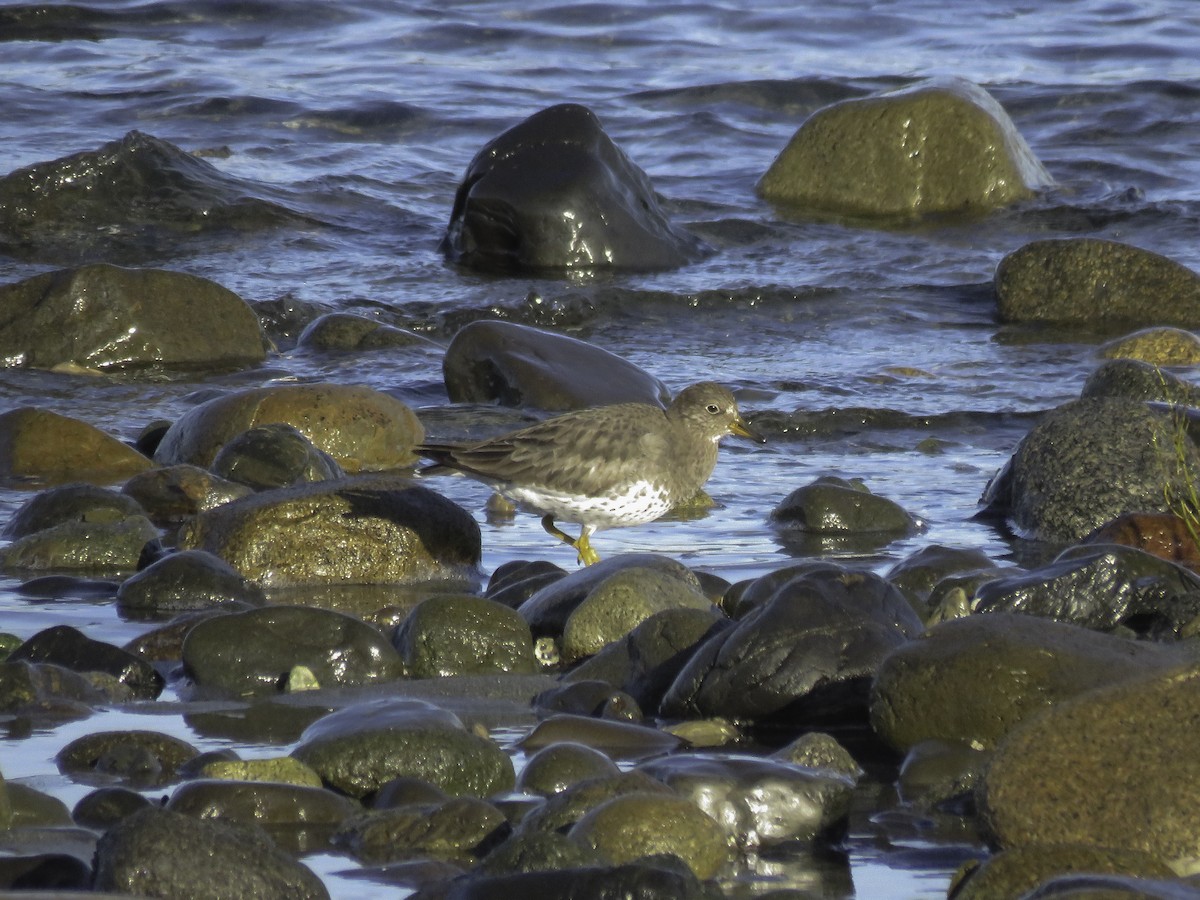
[416,382,763,565]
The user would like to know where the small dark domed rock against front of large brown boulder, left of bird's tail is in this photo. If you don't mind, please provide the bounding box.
[212,422,346,491]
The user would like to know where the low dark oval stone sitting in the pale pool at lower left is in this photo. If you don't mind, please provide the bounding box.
[54,731,197,788]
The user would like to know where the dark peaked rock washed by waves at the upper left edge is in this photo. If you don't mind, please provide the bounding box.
[0,131,299,262]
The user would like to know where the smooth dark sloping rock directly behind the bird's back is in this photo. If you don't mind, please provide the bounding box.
[442,320,671,410]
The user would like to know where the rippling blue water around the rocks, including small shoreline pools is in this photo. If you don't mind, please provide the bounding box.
[0,0,1200,896]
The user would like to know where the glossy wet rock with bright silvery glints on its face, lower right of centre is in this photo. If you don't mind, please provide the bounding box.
[638,754,854,851]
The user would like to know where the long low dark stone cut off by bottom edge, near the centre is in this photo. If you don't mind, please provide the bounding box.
[412,859,721,900]
